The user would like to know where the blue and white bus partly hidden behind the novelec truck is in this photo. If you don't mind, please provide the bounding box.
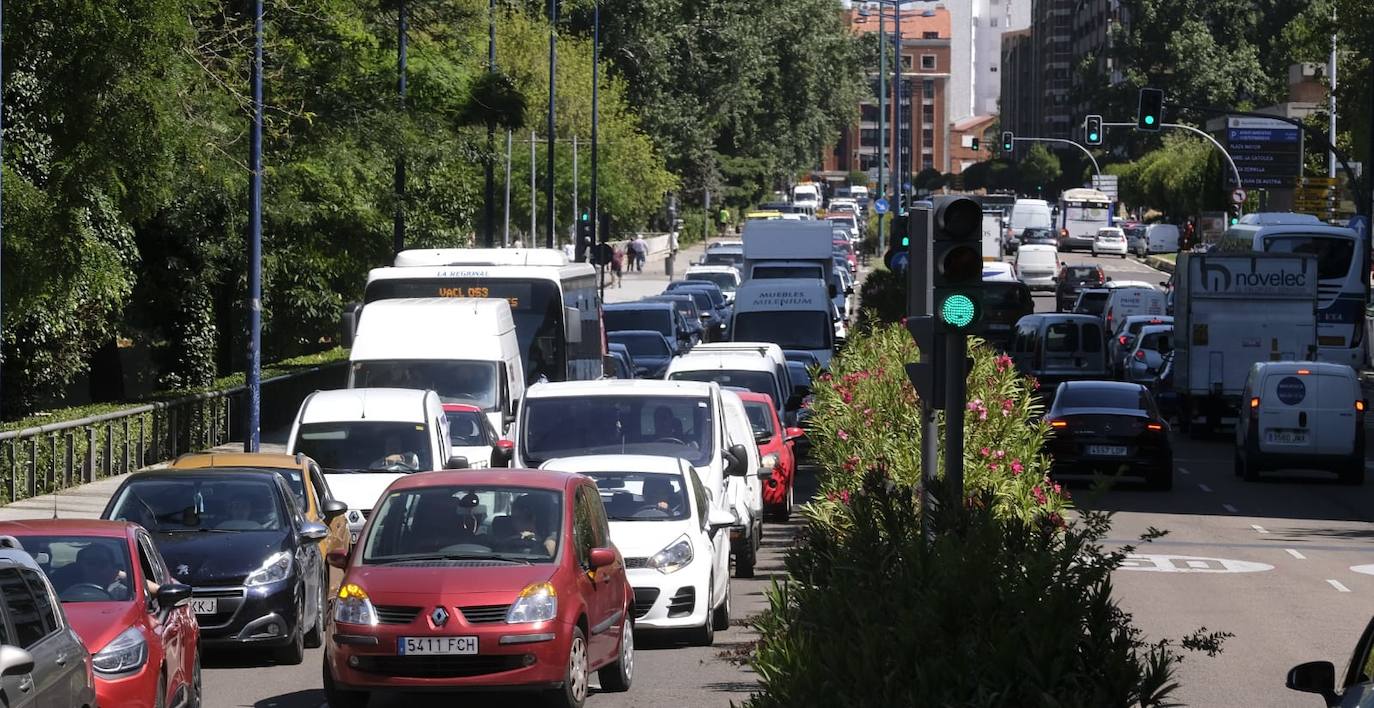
[1220,213,1369,370]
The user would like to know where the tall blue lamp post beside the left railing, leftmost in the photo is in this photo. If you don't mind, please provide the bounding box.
[243,0,262,452]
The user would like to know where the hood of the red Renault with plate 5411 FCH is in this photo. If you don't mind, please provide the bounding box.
[345,564,558,605]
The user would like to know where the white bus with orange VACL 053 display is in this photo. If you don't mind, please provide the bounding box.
[345,249,606,386]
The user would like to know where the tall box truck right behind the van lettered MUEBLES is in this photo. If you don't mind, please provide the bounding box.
[736,221,842,298]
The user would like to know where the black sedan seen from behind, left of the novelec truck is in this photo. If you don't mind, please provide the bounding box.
[1044,381,1173,489]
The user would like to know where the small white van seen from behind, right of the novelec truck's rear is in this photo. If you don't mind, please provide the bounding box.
[1235,362,1366,484]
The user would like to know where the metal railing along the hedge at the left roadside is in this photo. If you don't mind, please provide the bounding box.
[0,362,348,503]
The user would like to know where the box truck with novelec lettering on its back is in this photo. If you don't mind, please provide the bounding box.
[1173,253,1318,430]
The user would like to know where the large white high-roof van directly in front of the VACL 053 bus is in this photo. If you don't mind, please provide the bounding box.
[348,297,525,436]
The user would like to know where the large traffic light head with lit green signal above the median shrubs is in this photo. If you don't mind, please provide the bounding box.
[932,195,982,334]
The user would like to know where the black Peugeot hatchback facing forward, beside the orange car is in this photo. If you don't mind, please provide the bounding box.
[100,467,328,664]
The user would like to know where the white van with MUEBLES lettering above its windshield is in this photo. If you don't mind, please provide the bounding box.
[730,279,835,368]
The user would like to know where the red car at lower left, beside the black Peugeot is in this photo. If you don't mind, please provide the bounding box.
[0,520,201,708]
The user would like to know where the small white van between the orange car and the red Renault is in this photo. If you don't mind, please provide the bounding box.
[286,387,467,542]
